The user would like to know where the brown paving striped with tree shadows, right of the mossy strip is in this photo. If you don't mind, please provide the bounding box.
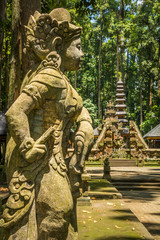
[88,167,160,240]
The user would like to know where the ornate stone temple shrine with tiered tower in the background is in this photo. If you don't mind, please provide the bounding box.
[92,80,154,178]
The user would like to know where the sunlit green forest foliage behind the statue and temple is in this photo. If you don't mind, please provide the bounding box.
[2,0,160,133]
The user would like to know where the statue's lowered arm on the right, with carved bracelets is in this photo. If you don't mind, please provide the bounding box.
[75,107,94,167]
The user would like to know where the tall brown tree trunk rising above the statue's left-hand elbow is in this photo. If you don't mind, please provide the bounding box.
[8,0,21,107]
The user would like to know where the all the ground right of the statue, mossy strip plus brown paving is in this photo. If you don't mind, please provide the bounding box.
[0,167,160,240]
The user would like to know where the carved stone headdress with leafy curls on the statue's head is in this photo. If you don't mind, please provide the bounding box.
[26,8,81,60]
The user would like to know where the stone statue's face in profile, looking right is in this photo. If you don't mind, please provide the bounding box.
[61,37,84,72]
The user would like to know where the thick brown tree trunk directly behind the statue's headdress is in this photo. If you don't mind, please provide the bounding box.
[20,0,41,78]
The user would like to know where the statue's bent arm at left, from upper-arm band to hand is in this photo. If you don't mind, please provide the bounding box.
[6,83,57,162]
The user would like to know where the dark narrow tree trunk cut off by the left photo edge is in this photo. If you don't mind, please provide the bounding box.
[0,0,6,112]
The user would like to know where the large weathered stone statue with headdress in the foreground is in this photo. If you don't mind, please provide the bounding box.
[0,8,93,240]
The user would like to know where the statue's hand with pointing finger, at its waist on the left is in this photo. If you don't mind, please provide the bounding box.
[20,138,47,163]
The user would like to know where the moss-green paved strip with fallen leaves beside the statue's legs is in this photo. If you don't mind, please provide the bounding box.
[78,199,154,240]
